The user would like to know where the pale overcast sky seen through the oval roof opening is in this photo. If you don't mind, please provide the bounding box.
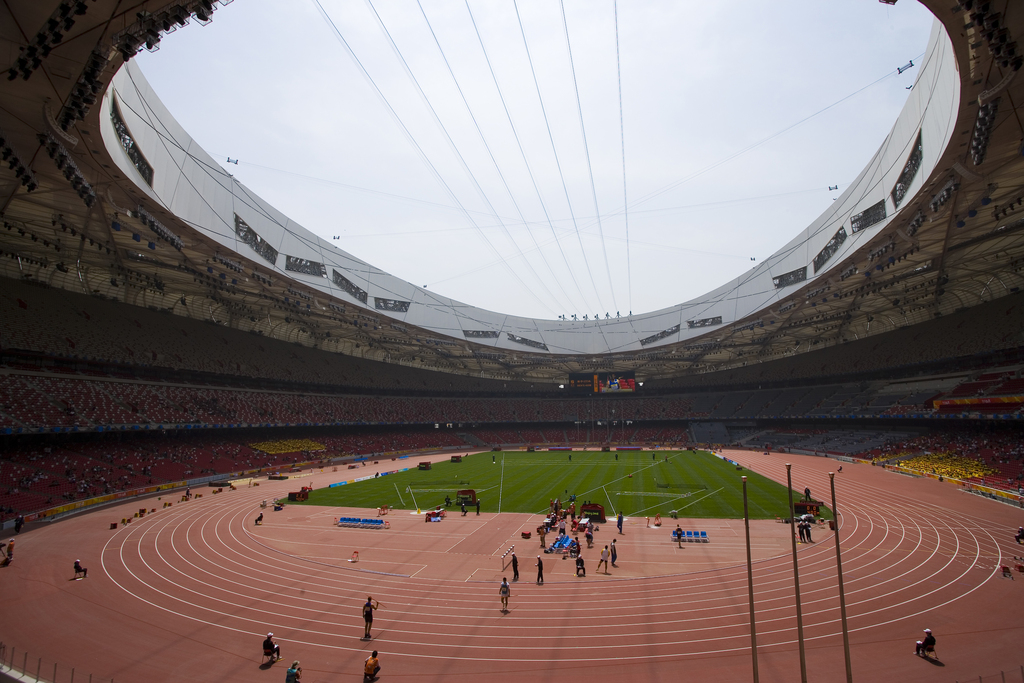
[137,0,933,319]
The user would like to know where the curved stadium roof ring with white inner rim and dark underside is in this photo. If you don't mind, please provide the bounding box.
[0,0,1024,381]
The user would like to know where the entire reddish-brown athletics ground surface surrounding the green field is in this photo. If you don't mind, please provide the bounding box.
[0,452,1024,683]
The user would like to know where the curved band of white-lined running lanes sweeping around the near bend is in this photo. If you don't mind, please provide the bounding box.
[100,456,1001,663]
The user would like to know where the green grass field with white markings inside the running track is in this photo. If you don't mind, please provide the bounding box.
[291,451,830,519]
